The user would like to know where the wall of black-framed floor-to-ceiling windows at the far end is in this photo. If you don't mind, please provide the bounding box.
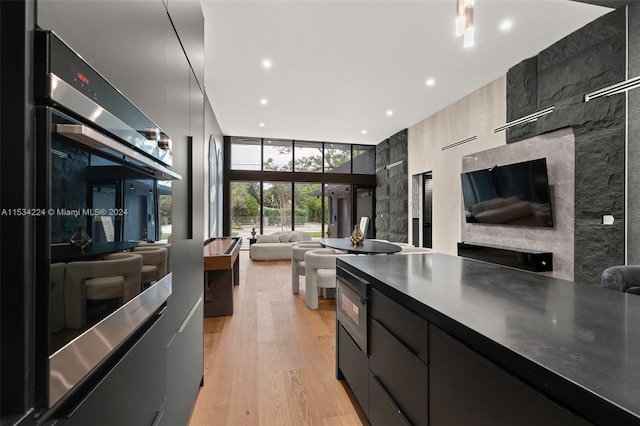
[224,137,375,240]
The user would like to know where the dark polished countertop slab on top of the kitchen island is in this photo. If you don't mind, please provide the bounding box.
[338,253,640,425]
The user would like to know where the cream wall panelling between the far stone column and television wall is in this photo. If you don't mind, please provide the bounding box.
[407,76,507,255]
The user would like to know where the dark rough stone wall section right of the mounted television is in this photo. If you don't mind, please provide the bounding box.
[507,9,626,285]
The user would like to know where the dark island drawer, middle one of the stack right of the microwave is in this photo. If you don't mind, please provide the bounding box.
[369,318,429,425]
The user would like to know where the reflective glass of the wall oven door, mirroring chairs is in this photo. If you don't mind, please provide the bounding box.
[48,122,171,354]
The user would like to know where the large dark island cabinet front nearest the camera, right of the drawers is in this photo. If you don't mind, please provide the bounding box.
[429,326,591,426]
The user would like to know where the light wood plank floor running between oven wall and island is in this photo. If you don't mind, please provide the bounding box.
[189,251,366,426]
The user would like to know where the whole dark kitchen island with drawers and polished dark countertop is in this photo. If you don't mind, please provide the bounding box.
[337,253,640,425]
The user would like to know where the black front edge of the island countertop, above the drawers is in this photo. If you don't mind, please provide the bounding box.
[337,257,640,426]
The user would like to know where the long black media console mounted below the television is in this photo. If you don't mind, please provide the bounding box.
[458,242,553,272]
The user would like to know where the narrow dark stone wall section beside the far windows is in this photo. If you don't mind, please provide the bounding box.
[376,129,409,243]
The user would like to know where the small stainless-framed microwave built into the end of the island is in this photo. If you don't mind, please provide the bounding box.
[336,278,369,355]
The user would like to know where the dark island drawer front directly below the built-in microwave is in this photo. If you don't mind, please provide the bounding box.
[338,323,369,417]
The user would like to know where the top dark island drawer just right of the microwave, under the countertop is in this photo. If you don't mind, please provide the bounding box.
[370,289,429,363]
